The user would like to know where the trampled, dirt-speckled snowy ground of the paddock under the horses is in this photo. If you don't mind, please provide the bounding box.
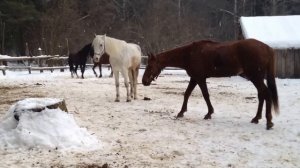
[0,69,300,168]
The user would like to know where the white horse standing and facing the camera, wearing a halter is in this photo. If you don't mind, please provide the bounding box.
[92,35,142,102]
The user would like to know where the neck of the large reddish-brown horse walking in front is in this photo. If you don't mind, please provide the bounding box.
[157,46,190,69]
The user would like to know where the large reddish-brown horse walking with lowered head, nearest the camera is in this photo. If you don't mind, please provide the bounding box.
[142,39,279,129]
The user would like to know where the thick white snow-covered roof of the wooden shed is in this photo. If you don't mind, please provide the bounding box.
[240,15,300,49]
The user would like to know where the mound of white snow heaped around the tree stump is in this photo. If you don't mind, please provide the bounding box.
[0,98,100,150]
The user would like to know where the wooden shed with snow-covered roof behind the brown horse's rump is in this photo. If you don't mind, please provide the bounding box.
[240,15,300,78]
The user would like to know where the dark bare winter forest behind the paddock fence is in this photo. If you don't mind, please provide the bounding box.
[0,0,300,56]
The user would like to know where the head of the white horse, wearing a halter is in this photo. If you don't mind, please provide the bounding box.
[92,35,105,62]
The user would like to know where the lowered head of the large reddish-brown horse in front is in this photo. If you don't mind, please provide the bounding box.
[142,54,162,86]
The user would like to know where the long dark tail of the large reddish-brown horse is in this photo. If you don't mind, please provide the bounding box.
[267,49,279,114]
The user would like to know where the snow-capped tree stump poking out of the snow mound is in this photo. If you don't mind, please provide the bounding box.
[13,98,68,121]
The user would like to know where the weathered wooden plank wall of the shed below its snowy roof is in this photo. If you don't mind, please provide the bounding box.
[275,49,300,78]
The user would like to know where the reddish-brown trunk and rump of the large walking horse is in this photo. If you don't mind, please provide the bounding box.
[190,39,273,77]
